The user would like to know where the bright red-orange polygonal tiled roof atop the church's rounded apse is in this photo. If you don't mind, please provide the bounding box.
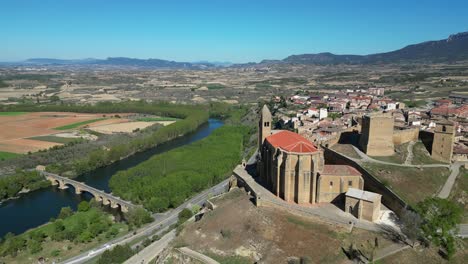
[266,130,317,153]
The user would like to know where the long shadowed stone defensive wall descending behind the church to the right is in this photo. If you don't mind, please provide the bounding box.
[323,147,410,216]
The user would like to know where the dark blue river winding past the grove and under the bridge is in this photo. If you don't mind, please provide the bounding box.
[0,119,223,237]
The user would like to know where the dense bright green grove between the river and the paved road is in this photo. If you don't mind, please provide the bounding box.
[109,126,248,212]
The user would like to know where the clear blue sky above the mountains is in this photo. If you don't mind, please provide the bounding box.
[0,0,468,62]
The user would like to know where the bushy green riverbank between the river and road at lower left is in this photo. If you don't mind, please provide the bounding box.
[0,204,129,263]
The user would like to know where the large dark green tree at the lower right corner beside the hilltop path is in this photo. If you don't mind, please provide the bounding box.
[416,197,463,259]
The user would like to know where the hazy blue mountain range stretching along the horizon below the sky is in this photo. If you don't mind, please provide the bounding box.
[0,32,468,69]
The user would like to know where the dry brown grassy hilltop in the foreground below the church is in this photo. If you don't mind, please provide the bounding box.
[176,190,392,263]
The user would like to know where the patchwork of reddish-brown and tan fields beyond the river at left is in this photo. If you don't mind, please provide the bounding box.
[0,112,159,154]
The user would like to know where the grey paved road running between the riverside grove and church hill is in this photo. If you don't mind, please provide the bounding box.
[63,179,229,264]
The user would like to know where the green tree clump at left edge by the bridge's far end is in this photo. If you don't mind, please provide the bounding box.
[0,171,49,201]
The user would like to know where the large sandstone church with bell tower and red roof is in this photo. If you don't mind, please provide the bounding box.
[257,105,364,204]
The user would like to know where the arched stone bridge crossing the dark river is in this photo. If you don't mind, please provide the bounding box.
[40,171,136,213]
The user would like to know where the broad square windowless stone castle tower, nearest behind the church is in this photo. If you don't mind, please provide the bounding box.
[359,113,394,156]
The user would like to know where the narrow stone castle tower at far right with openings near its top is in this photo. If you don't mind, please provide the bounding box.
[431,121,455,163]
